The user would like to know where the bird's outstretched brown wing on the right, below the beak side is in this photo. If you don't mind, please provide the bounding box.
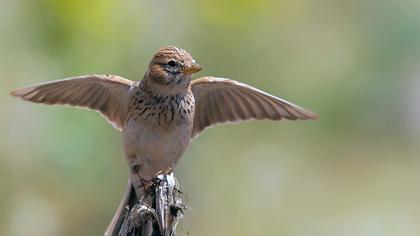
[191,77,317,137]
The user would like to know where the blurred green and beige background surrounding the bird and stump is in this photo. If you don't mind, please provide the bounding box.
[0,0,420,236]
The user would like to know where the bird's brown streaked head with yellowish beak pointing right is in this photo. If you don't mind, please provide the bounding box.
[145,46,203,93]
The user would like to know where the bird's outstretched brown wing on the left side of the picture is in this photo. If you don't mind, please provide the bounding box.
[10,75,134,130]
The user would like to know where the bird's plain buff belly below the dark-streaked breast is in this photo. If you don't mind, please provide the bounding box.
[122,121,191,185]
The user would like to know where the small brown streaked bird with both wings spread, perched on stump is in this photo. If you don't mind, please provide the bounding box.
[10,46,318,232]
